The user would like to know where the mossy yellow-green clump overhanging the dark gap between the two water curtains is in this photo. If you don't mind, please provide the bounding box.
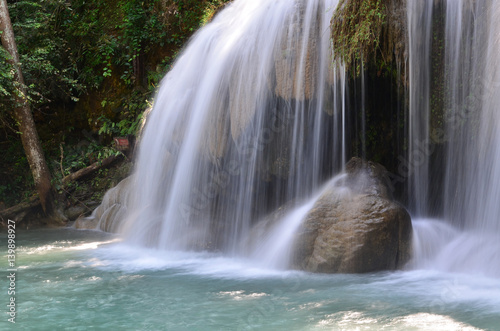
[331,0,386,75]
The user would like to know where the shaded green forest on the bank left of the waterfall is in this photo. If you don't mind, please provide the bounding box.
[0,0,229,210]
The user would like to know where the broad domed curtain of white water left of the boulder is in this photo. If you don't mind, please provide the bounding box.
[118,0,346,252]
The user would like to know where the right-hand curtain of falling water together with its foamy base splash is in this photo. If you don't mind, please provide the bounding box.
[408,0,500,277]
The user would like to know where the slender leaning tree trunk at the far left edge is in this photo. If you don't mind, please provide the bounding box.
[0,0,53,214]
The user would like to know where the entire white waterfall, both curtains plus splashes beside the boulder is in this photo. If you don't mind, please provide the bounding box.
[83,0,500,277]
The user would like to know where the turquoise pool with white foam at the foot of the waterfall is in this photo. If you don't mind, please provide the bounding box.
[0,229,500,331]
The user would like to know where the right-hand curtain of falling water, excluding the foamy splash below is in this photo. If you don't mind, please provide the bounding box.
[408,0,500,235]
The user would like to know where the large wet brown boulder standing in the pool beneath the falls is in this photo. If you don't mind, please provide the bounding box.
[292,158,412,273]
